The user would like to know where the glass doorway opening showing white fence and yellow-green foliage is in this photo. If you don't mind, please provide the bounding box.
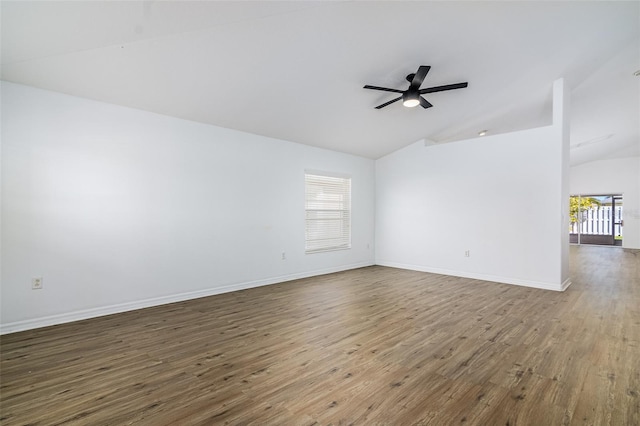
[569,194,624,246]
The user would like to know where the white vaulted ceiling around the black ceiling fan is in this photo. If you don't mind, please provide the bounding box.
[0,0,640,164]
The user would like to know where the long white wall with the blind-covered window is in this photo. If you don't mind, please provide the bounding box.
[0,82,374,332]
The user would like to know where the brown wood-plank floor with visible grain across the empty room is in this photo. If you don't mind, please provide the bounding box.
[0,246,640,425]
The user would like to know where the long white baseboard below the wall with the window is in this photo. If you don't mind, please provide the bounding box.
[0,262,374,335]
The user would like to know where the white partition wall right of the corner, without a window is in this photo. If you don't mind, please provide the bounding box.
[376,126,567,290]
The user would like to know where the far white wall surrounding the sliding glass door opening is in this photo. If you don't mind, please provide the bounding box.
[570,157,640,249]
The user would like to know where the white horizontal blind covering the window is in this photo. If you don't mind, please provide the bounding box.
[304,173,351,253]
